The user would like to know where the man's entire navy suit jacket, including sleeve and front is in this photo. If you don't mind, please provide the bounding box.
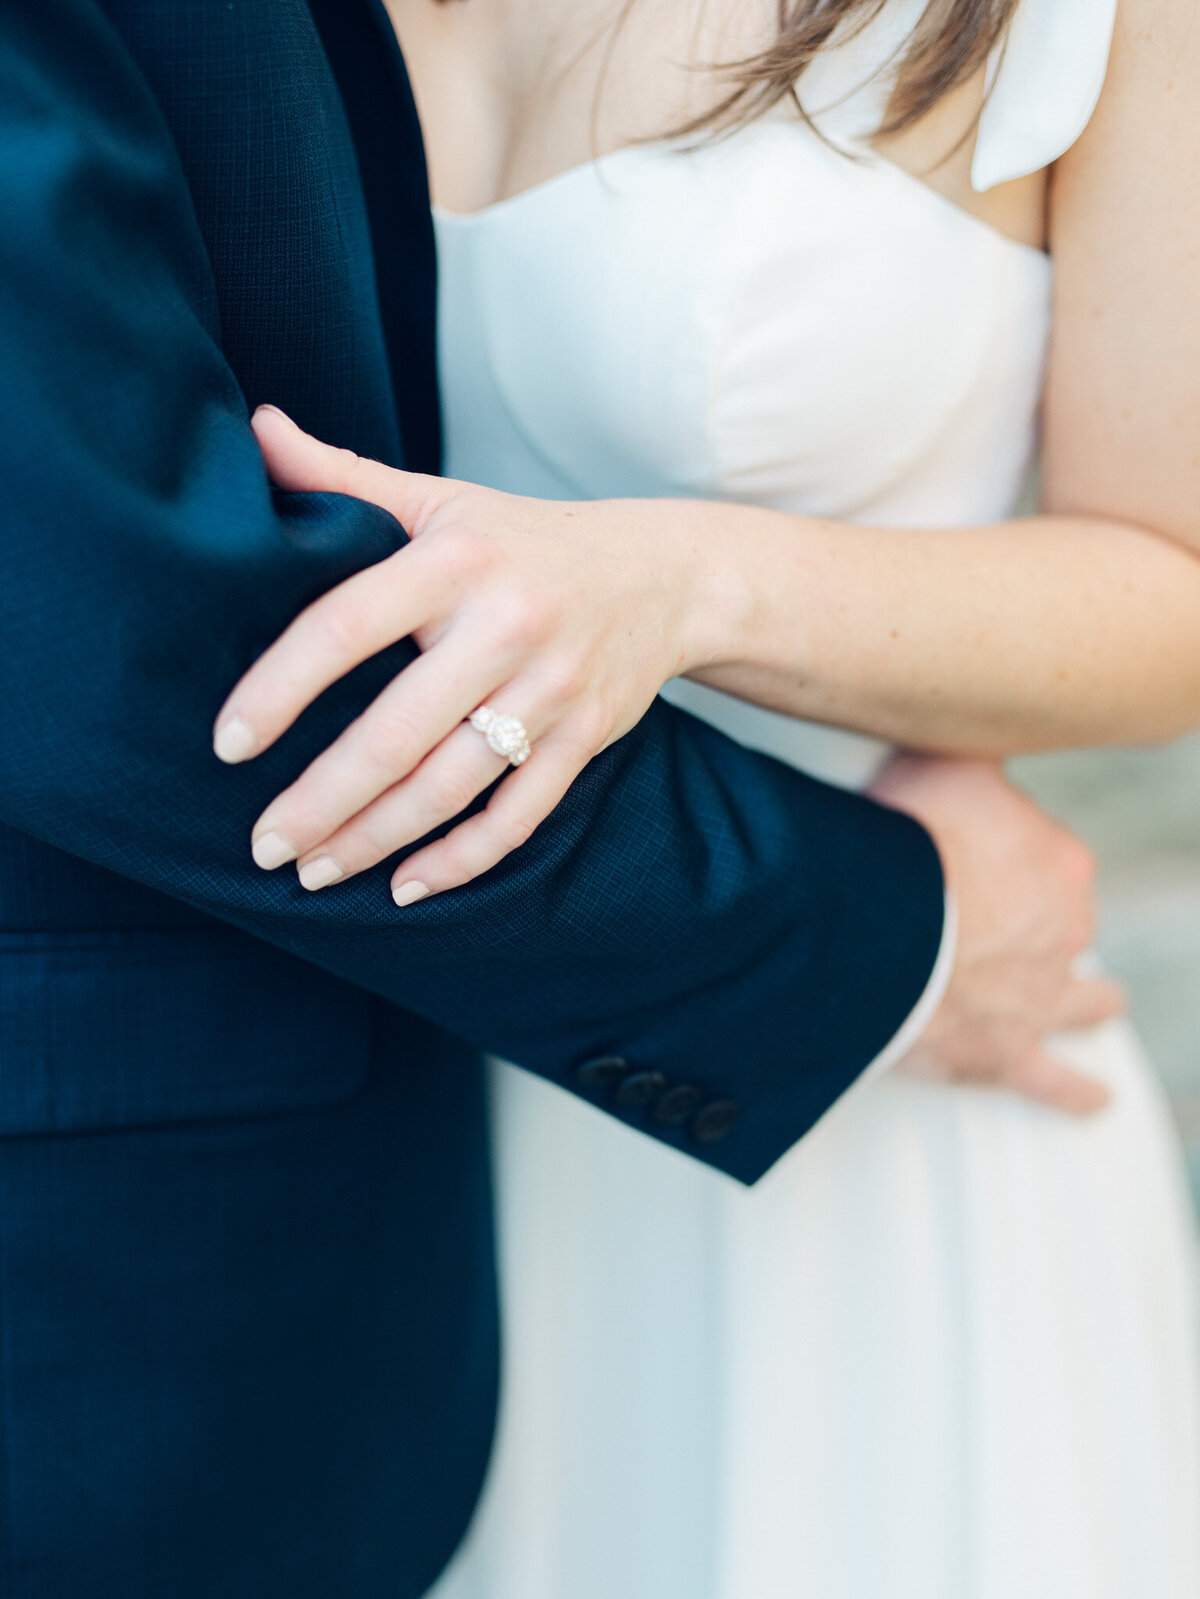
[0,0,942,1599]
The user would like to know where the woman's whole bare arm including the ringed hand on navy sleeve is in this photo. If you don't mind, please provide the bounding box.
[218,0,1200,887]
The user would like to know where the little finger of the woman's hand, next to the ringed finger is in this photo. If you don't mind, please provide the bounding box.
[392,742,584,905]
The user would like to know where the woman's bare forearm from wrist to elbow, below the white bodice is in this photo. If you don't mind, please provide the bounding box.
[690,505,1200,755]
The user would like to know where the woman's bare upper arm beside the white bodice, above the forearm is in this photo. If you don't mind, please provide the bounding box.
[1045,0,1200,548]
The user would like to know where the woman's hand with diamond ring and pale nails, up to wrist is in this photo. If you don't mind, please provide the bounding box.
[214,408,729,905]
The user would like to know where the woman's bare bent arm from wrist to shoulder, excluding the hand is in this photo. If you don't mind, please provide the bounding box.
[699,0,1200,753]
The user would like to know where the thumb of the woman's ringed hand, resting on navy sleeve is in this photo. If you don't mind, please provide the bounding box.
[250,405,459,534]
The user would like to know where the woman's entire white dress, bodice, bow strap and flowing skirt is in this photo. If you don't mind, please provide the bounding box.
[435,0,1200,1599]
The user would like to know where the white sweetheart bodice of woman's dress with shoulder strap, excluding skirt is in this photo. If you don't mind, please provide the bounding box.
[437,0,1114,780]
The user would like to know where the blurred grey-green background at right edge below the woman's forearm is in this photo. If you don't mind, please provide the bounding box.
[1010,736,1200,1210]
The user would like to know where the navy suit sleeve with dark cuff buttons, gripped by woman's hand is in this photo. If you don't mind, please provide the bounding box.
[0,0,942,1182]
